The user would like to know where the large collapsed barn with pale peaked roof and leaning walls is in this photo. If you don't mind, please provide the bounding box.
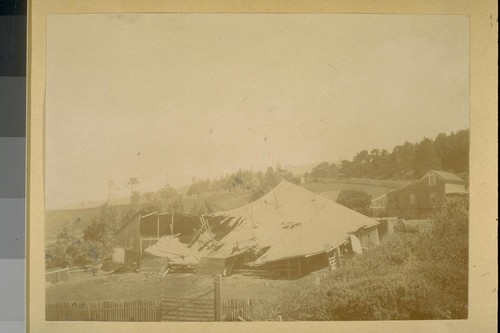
[194,181,379,278]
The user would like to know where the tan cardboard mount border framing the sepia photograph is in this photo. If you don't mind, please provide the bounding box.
[26,0,498,333]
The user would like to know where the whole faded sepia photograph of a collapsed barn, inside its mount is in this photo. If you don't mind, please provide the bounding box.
[39,13,470,322]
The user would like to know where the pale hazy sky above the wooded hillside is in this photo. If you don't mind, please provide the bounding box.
[45,14,469,209]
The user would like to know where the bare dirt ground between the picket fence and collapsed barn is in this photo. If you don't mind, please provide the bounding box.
[46,272,322,303]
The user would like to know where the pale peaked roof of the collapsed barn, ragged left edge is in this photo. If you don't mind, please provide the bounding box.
[200,181,378,266]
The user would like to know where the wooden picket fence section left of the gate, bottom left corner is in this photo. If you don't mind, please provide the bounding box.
[45,300,161,321]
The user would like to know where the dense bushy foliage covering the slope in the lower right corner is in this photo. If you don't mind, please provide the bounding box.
[266,197,469,320]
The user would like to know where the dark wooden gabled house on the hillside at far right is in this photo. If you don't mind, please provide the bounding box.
[372,170,468,218]
